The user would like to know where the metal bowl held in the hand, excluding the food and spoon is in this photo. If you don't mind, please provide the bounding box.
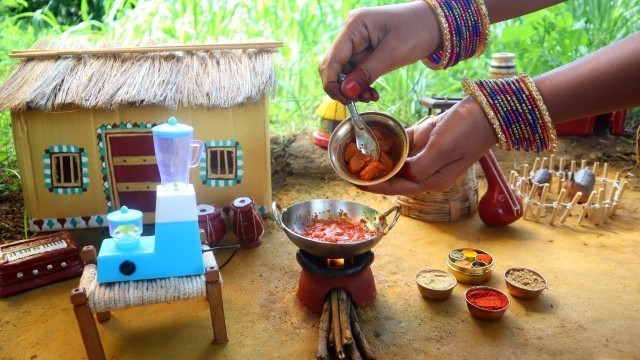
[327,111,409,185]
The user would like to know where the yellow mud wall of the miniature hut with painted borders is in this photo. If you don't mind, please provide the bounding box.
[12,99,271,231]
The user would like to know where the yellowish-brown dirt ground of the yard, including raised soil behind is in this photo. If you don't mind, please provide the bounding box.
[0,128,640,359]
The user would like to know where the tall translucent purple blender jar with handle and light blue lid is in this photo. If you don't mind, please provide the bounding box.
[151,117,204,190]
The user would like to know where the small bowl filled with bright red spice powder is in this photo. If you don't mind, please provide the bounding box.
[464,286,511,321]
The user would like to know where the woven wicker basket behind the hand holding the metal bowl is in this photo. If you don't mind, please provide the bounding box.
[393,165,478,222]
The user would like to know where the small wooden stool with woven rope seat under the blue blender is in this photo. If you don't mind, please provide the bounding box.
[71,246,228,360]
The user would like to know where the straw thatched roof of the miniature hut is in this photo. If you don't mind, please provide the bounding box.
[0,41,281,111]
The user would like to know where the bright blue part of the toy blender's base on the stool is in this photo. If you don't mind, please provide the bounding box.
[97,221,204,283]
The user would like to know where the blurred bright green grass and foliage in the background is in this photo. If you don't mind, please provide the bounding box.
[0,0,640,192]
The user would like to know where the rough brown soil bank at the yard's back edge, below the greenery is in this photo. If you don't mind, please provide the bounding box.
[0,133,640,243]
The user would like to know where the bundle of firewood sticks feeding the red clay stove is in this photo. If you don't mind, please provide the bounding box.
[316,289,375,360]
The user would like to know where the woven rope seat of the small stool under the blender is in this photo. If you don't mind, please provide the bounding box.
[80,252,222,313]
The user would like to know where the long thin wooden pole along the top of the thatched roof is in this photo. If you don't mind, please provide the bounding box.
[9,41,283,59]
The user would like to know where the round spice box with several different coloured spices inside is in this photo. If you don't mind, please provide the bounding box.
[446,248,495,285]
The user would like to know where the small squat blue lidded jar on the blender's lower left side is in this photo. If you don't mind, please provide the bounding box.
[107,206,142,250]
